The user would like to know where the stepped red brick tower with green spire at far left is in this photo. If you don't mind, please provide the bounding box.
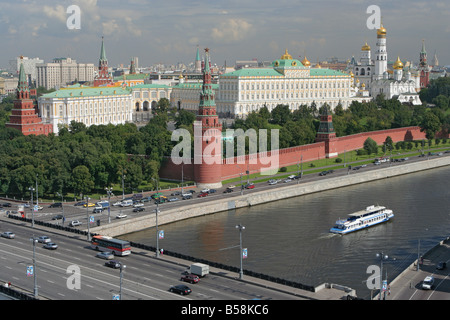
[5,63,53,135]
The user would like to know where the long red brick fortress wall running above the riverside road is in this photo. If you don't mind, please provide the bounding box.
[159,127,426,183]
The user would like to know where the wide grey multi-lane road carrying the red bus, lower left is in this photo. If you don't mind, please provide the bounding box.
[0,218,299,301]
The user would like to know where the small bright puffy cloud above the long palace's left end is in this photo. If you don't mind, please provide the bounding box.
[211,19,252,43]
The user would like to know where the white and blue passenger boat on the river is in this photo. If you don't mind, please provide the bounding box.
[330,205,394,234]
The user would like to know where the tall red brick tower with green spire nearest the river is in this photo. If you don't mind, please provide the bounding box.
[194,49,222,188]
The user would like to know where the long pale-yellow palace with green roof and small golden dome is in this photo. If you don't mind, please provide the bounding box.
[217,50,353,118]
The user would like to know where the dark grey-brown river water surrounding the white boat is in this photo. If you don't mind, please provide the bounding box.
[120,167,450,299]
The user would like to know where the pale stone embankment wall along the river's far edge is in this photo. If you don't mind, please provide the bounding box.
[91,156,450,236]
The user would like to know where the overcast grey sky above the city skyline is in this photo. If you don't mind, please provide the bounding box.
[0,0,450,67]
